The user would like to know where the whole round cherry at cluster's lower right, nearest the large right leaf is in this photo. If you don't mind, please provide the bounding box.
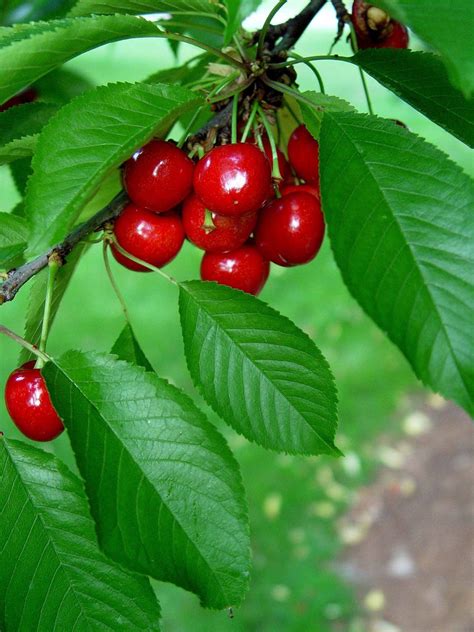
[255,192,324,267]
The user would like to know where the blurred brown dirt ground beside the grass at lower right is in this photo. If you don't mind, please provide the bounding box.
[339,397,474,632]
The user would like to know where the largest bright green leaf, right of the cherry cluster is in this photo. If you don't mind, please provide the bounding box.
[320,113,474,412]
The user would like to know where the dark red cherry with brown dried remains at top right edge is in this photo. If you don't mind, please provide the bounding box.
[351,0,408,49]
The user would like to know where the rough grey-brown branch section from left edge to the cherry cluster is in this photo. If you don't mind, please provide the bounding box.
[0,191,128,305]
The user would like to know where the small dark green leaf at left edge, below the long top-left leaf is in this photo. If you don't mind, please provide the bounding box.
[0,103,58,165]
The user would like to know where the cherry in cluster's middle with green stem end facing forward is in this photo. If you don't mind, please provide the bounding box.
[182,193,257,252]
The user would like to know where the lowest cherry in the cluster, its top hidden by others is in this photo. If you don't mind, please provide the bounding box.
[201,244,270,295]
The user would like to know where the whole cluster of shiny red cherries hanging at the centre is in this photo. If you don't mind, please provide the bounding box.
[112,125,324,294]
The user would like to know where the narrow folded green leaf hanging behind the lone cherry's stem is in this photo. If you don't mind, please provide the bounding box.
[19,244,87,364]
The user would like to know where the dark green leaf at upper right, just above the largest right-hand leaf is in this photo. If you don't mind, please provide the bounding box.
[352,48,474,147]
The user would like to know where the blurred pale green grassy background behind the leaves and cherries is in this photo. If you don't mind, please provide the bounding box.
[0,2,472,632]
